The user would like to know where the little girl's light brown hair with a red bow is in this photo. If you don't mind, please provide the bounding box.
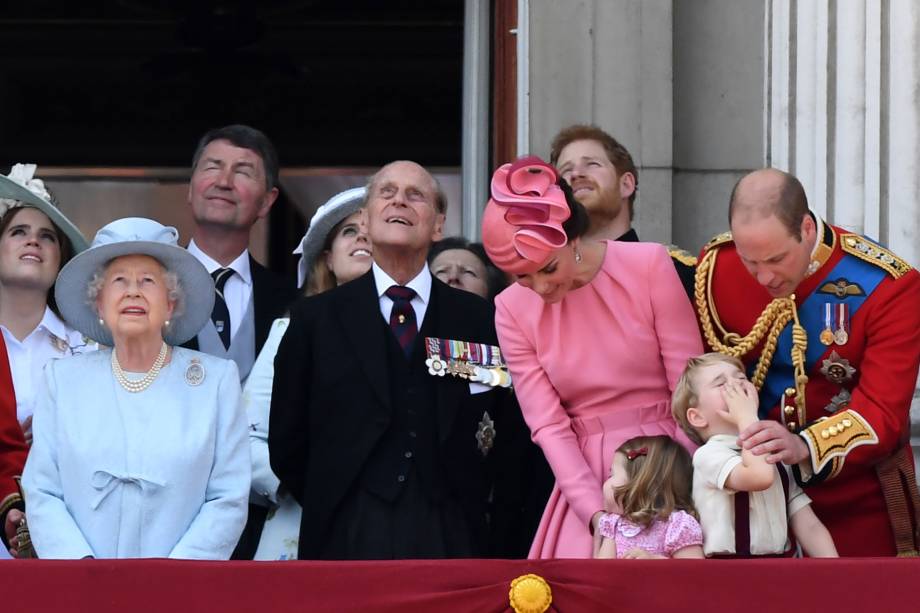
[614,436,699,526]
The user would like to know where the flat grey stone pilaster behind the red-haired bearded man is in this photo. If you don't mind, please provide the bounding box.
[518,0,673,242]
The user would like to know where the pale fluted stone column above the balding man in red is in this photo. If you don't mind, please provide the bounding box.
[765,0,920,474]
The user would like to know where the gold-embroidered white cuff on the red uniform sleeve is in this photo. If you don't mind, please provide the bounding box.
[801,409,878,479]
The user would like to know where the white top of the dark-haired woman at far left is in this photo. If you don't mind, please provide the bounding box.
[0,306,96,423]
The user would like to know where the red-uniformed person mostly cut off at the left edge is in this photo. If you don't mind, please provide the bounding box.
[0,334,28,548]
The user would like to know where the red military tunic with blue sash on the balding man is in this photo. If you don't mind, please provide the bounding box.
[696,219,920,556]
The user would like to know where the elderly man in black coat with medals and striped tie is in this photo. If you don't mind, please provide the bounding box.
[269,161,511,559]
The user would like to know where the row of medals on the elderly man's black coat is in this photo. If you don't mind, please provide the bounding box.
[425,336,511,387]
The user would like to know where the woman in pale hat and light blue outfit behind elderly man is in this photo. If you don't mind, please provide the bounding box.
[243,187,373,560]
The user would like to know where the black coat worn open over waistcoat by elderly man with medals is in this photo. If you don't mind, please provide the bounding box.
[268,271,510,559]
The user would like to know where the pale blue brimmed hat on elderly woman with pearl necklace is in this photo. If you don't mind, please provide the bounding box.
[54,217,214,345]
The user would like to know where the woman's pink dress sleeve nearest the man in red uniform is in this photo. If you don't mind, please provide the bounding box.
[648,247,703,454]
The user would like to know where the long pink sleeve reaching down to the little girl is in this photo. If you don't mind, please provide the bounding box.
[495,294,604,526]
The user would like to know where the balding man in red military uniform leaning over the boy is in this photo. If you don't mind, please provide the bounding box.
[695,169,920,556]
